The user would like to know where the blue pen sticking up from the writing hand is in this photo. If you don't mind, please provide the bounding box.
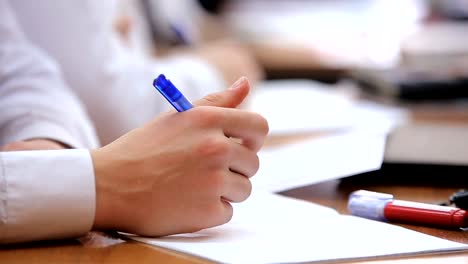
[153,74,193,112]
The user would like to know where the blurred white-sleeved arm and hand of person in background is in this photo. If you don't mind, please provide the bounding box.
[137,0,264,84]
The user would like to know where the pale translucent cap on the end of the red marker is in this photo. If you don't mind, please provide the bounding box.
[348,190,393,221]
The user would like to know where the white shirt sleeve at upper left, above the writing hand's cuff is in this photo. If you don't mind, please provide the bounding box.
[0,1,98,148]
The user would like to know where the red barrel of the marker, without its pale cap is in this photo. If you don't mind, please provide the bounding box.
[384,200,468,228]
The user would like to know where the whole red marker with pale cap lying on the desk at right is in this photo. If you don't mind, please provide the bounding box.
[348,190,468,229]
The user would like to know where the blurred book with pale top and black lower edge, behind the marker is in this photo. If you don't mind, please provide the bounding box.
[341,122,468,188]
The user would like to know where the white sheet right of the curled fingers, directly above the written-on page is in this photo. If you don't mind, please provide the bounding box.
[252,133,385,192]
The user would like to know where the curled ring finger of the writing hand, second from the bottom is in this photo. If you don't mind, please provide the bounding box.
[222,171,252,203]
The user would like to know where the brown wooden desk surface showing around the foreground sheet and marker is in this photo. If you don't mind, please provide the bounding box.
[0,161,468,264]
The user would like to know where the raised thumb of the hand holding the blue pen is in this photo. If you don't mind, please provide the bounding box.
[193,77,250,108]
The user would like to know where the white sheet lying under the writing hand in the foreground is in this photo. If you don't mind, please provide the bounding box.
[131,191,468,264]
